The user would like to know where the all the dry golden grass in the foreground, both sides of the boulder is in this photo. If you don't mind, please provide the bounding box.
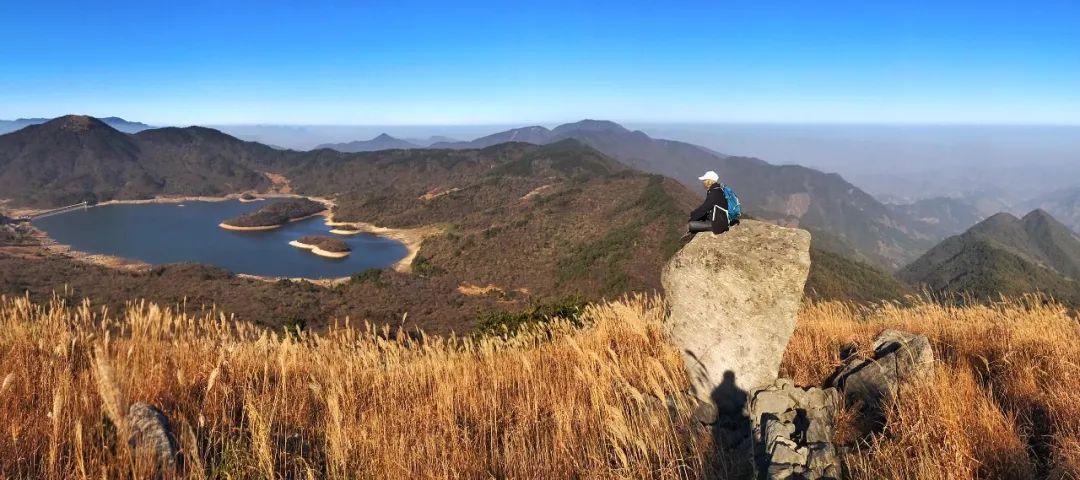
[0,297,1080,479]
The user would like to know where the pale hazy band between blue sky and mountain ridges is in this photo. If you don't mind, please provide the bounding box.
[0,118,1080,207]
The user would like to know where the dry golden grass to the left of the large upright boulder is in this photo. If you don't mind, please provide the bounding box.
[0,298,708,478]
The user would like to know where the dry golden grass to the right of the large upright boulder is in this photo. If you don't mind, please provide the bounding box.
[781,298,1080,479]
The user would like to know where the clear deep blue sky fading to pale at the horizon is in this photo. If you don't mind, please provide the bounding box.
[0,0,1080,124]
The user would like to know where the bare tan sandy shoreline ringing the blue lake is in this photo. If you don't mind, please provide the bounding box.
[0,194,434,286]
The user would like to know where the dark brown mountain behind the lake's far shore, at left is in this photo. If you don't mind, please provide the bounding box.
[0,116,278,206]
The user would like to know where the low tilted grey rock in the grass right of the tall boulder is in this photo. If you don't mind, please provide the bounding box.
[827,330,934,429]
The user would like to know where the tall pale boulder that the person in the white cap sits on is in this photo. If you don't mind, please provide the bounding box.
[662,219,810,406]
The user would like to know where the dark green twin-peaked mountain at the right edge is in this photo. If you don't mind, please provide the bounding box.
[899,210,1080,305]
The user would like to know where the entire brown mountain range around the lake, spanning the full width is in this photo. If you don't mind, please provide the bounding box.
[0,116,1080,328]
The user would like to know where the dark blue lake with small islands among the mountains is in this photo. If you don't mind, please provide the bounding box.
[33,200,408,279]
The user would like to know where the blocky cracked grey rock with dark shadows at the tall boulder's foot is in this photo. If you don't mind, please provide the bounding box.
[750,378,840,480]
